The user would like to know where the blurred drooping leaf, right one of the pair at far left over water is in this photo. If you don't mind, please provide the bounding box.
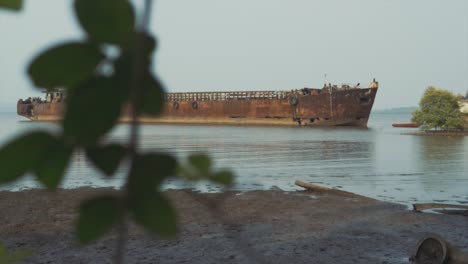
[34,139,73,190]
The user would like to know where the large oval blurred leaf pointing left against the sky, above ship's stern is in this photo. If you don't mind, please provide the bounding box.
[28,42,104,88]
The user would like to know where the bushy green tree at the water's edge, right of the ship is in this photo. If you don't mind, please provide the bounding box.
[411,86,463,130]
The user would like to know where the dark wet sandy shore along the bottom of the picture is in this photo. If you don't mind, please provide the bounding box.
[0,188,468,264]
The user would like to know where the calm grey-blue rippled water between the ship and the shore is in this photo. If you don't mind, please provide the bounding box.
[0,108,468,203]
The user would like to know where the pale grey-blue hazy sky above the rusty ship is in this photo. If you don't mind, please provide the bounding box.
[0,0,468,109]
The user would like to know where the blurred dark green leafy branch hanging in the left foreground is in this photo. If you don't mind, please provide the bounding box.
[0,0,233,263]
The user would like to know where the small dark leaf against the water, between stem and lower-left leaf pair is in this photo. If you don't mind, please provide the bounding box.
[86,144,126,176]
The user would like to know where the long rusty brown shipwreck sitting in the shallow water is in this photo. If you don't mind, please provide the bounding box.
[17,79,378,127]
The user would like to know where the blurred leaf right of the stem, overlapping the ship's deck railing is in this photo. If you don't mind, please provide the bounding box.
[142,73,164,116]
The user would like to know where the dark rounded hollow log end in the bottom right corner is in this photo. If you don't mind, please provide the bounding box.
[410,235,468,264]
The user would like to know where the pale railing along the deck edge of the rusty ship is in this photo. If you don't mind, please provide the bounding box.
[165,91,289,102]
